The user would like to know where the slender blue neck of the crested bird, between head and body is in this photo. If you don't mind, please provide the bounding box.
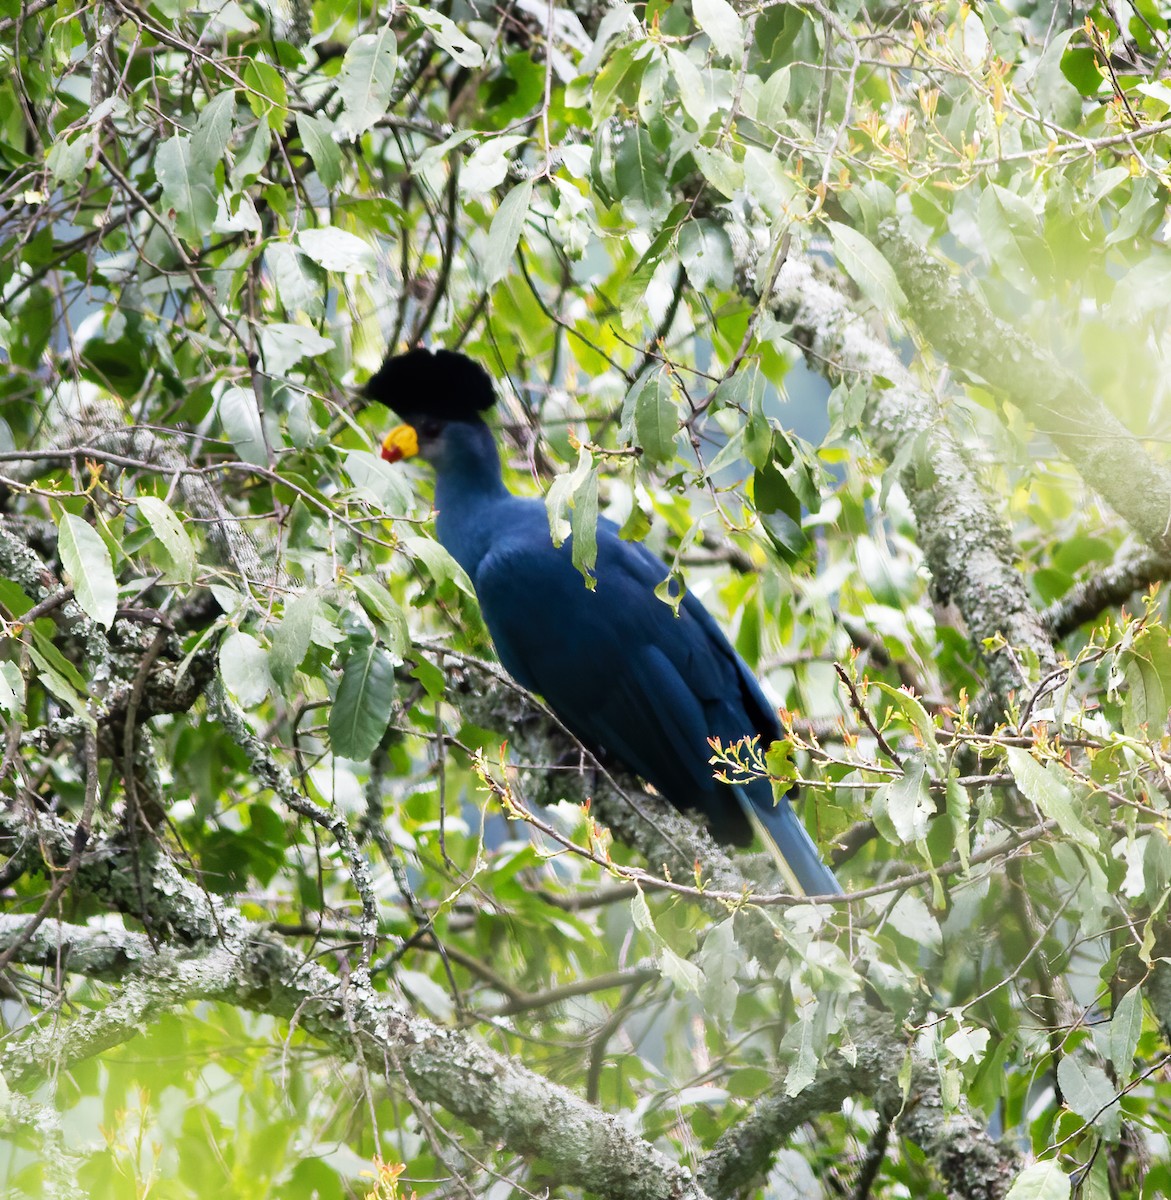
[436,421,512,578]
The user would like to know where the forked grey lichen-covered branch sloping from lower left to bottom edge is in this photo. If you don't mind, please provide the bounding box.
[0,916,705,1200]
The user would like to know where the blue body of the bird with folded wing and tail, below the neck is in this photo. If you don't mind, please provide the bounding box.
[473,502,840,894]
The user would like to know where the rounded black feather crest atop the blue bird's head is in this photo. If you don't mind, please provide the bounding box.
[365,349,496,421]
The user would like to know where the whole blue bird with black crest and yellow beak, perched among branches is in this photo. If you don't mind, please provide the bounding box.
[365,347,841,895]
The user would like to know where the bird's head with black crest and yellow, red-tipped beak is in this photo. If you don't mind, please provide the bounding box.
[365,349,496,467]
